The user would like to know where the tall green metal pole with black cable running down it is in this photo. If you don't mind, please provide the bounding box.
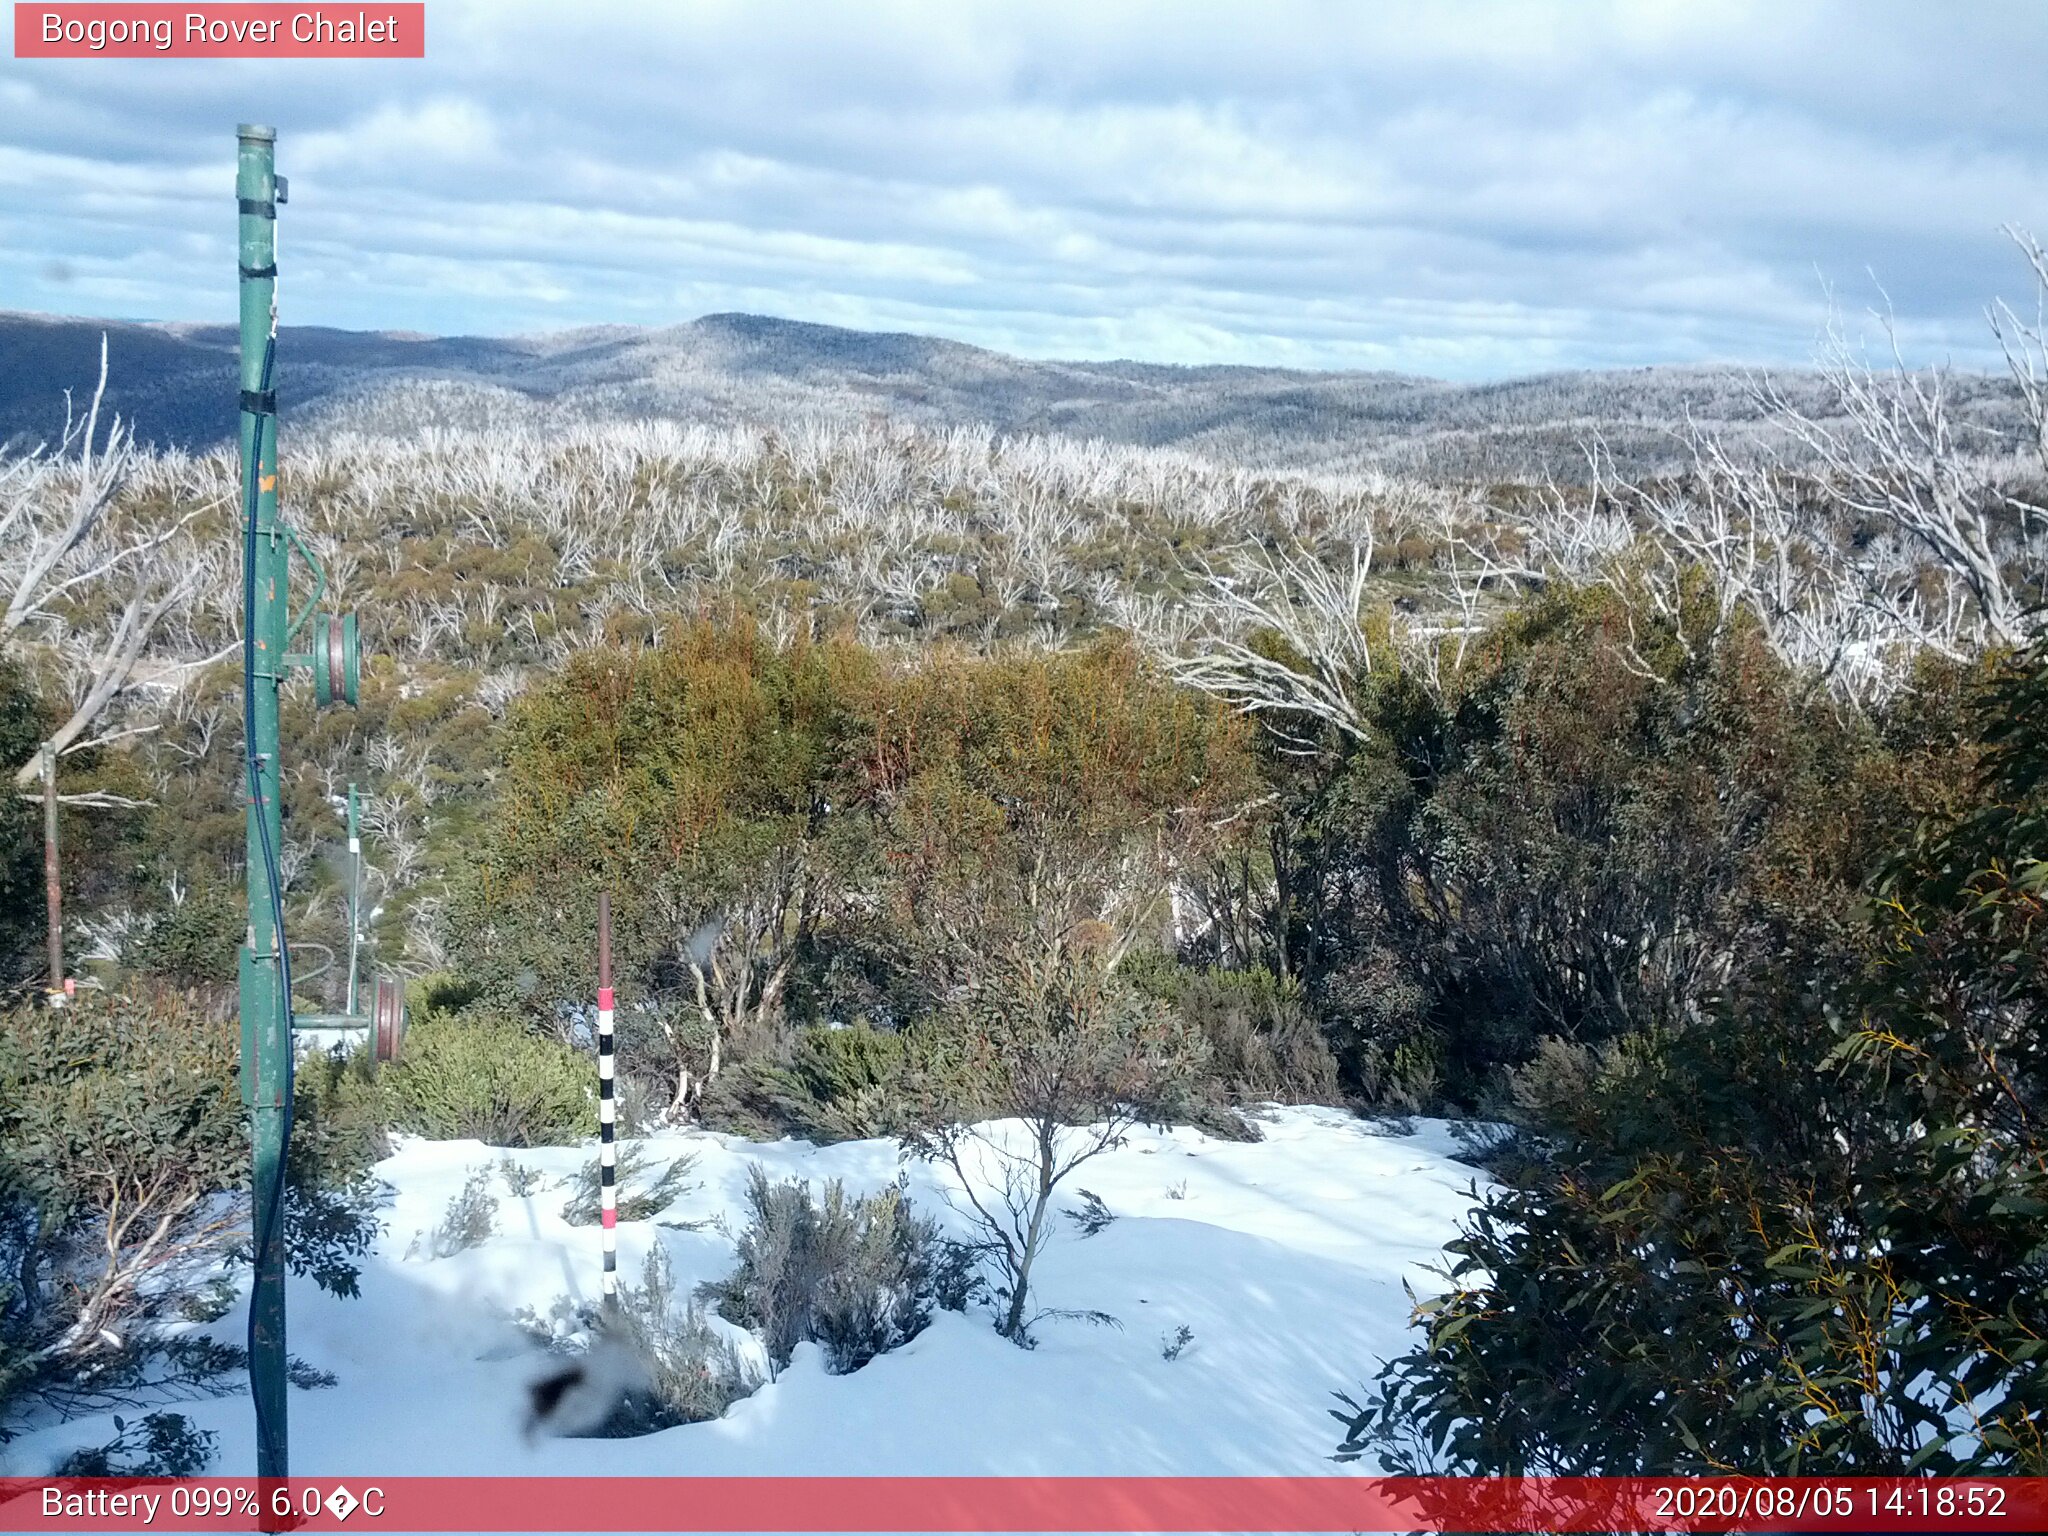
[236,123,291,1477]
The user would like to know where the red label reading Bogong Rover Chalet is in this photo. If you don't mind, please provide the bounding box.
[14,0,426,59]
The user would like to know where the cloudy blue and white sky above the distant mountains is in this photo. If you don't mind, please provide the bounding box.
[0,0,2048,379]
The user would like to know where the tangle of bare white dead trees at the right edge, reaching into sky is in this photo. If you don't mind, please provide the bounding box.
[1499,229,2048,705]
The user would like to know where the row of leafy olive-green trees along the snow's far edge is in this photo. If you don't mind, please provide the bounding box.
[391,590,1974,1135]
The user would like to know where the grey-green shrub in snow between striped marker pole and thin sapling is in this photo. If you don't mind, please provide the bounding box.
[698,1165,969,1374]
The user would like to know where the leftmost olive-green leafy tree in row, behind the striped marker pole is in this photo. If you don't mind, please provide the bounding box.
[449,621,874,1040]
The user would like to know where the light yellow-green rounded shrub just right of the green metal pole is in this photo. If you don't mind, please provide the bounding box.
[383,1014,598,1147]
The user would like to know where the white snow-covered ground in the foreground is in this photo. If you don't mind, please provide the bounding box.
[6,1108,1483,1477]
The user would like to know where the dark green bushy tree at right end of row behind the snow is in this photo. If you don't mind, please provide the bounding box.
[1282,590,1954,1110]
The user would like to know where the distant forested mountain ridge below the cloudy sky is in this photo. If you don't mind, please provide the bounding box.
[0,311,2005,479]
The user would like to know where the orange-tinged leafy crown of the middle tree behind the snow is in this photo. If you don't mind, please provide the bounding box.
[854,643,1255,1008]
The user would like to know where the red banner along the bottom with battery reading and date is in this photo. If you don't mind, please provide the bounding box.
[0,1475,2048,1532]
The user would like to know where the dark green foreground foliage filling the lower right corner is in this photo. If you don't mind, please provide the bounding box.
[1339,653,2048,1475]
